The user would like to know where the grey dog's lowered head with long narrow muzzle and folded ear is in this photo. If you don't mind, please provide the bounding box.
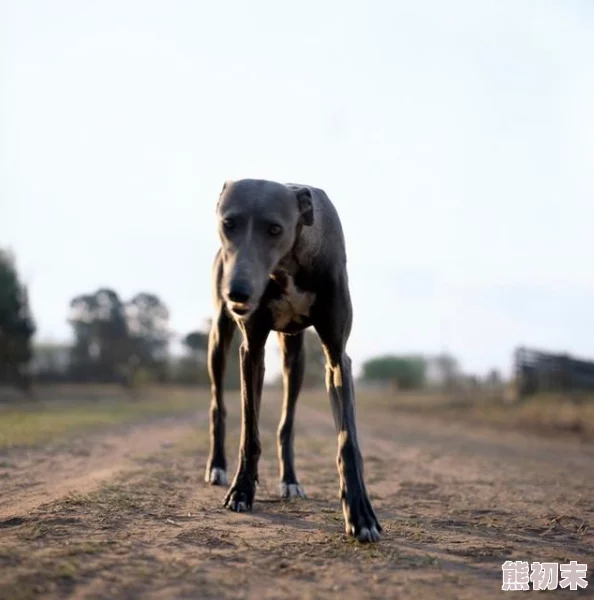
[217,179,313,318]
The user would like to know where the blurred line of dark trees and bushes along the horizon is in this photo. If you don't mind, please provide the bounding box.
[0,250,472,389]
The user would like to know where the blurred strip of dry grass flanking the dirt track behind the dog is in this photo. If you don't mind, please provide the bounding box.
[0,385,594,449]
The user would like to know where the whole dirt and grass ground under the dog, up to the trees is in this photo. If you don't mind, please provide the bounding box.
[0,388,594,600]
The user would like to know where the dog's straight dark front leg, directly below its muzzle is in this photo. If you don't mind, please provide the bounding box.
[223,330,267,512]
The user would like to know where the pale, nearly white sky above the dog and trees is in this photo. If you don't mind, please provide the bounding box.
[0,0,594,376]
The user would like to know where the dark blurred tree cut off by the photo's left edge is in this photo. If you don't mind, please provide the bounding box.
[0,250,35,388]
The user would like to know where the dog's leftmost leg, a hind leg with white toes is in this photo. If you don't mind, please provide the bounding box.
[204,304,235,485]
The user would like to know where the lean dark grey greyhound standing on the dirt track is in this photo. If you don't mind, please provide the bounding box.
[205,179,382,542]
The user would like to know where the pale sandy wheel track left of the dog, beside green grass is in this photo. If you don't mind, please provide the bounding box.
[0,413,201,523]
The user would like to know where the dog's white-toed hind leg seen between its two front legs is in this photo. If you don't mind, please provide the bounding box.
[277,332,305,498]
